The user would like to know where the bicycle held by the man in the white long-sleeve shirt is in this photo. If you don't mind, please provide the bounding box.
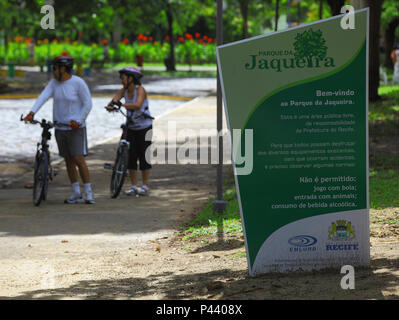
[20,115,70,206]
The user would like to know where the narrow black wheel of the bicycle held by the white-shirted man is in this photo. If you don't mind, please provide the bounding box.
[33,152,48,206]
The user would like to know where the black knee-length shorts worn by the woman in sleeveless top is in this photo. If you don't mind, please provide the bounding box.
[127,126,152,170]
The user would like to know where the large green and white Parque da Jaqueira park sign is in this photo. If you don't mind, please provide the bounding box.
[217,9,370,275]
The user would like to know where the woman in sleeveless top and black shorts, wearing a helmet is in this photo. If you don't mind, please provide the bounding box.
[107,67,153,195]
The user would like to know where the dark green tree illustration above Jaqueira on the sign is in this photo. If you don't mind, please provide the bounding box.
[294,29,327,67]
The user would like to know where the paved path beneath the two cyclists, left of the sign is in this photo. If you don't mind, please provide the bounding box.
[0,96,229,297]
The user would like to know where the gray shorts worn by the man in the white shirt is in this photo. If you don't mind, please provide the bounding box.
[55,127,88,158]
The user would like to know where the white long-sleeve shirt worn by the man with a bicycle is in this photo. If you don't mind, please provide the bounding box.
[31,76,92,130]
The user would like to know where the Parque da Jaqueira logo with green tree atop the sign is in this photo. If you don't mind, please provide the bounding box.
[244,29,335,72]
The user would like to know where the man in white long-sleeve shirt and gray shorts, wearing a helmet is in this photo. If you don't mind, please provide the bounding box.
[24,56,95,204]
